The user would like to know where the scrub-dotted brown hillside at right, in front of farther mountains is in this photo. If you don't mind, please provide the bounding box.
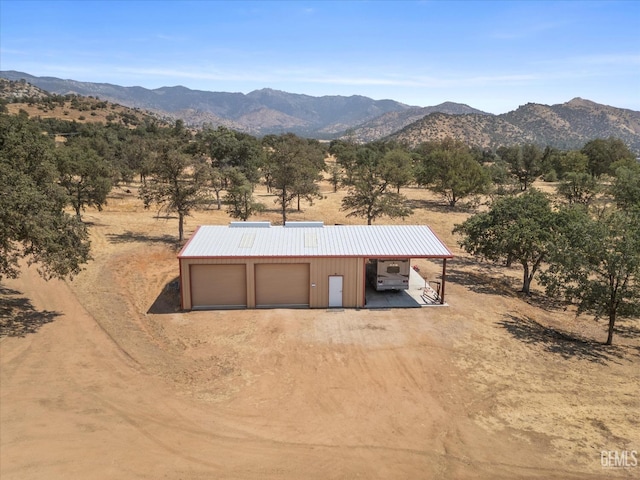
[387,98,640,152]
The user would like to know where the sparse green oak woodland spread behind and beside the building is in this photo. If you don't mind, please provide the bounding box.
[0,89,640,344]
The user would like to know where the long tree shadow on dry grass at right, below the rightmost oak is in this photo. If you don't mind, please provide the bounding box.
[498,314,640,365]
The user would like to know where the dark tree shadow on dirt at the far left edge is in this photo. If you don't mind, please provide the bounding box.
[0,286,61,338]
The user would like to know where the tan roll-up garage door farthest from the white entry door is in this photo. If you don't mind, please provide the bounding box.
[190,265,247,309]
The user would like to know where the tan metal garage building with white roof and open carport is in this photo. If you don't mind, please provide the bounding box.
[178,222,453,310]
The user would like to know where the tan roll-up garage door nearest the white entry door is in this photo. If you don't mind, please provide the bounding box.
[256,263,309,307]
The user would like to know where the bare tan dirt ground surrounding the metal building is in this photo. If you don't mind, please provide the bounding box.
[0,182,640,480]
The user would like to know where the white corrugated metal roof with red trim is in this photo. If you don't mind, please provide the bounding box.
[178,225,453,258]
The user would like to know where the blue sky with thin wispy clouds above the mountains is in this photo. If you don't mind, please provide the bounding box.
[0,0,640,113]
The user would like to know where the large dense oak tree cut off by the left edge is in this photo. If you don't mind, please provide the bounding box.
[0,115,91,279]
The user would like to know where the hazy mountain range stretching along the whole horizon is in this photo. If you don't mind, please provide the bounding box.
[0,71,640,153]
